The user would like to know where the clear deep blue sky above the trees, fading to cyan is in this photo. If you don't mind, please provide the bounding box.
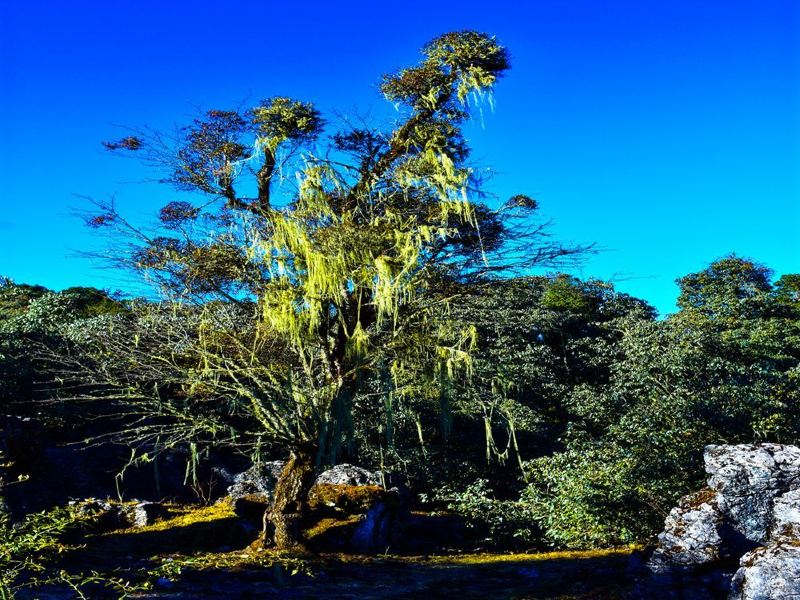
[0,0,800,313]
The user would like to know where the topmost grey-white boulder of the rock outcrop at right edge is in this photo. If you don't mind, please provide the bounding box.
[704,444,800,543]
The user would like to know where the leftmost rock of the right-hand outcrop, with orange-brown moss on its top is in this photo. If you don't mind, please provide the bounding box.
[648,488,725,573]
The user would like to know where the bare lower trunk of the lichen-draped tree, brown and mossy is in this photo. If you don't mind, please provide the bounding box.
[262,446,314,550]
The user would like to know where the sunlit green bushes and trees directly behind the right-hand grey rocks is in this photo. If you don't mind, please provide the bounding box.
[523,257,800,546]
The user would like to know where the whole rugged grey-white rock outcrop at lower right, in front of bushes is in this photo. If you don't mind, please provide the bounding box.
[648,444,800,600]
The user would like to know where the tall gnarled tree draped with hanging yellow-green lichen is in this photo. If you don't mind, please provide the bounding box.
[76,31,585,548]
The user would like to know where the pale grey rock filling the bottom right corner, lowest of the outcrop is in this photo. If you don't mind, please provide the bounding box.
[728,541,800,600]
